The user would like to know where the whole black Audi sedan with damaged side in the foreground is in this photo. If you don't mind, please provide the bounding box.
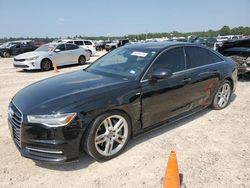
[8,42,237,163]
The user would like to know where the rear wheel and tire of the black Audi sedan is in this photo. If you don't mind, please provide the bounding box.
[211,80,232,110]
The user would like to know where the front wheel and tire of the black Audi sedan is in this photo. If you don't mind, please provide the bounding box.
[83,111,131,161]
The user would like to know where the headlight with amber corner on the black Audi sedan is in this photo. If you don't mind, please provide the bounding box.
[27,113,76,127]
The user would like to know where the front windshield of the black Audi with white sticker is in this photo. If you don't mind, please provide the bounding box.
[87,48,157,80]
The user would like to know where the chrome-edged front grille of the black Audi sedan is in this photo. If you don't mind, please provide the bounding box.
[8,103,23,147]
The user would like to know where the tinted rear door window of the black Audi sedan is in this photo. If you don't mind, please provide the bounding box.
[185,46,213,68]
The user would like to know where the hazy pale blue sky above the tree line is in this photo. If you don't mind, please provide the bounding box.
[0,0,250,38]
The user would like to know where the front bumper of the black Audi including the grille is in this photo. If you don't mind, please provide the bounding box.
[8,103,84,163]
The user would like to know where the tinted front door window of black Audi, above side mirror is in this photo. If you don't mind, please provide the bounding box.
[149,48,185,72]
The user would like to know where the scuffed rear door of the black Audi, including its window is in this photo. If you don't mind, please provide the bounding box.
[185,46,223,107]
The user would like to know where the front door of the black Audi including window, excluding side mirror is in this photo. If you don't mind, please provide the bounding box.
[141,47,192,128]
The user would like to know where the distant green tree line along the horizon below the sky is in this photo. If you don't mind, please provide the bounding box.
[0,25,250,43]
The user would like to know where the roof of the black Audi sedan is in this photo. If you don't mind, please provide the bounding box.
[125,41,194,50]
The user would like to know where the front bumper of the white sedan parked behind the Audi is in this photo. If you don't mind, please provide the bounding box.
[13,59,40,70]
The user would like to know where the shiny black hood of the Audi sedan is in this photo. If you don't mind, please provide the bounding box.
[13,70,129,114]
